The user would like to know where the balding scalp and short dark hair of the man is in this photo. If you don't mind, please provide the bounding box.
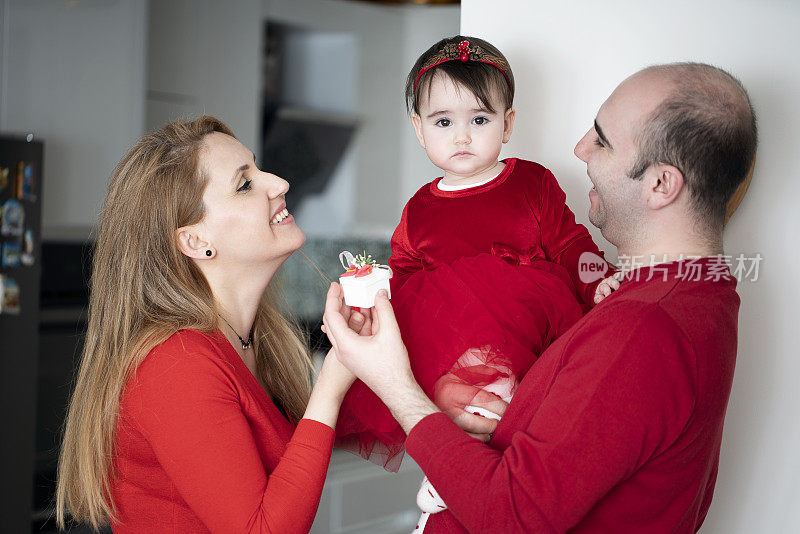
[629,63,757,229]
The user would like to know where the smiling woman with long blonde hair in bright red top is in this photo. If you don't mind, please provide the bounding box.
[57,116,370,533]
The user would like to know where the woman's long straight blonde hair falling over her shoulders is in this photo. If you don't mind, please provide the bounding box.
[56,115,311,529]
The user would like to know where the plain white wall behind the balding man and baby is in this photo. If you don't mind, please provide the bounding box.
[461,0,800,534]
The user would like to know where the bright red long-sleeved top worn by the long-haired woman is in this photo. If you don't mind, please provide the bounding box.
[111,330,334,534]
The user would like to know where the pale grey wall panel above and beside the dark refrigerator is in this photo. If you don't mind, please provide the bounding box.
[0,0,147,237]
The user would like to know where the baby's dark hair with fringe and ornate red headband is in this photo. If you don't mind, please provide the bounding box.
[406,35,514,114]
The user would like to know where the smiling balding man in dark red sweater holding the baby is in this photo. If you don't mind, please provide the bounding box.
[325,63,757,533]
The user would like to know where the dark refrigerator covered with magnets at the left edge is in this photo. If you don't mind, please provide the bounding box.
[0,135,44,532]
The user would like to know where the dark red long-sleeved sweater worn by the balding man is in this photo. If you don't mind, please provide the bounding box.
[406,259,739,534]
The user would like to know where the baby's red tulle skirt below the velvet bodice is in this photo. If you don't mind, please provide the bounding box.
[336,254,582,471]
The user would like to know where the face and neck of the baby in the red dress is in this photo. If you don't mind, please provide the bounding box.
[411,74,514,185]
